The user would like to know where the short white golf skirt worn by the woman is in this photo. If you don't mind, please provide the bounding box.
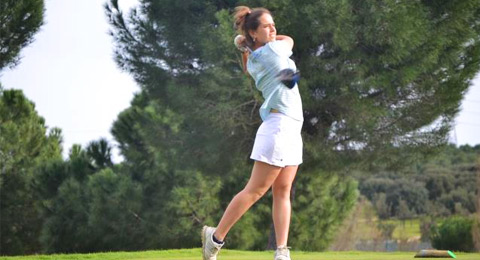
[250,113,303,167]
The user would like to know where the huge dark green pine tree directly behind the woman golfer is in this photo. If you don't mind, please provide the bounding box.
[106,0,480,250]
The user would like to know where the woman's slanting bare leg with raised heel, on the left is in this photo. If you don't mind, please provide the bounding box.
[214,161,283,240]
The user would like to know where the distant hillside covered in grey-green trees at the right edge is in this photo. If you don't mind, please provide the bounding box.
[357,145,480,219]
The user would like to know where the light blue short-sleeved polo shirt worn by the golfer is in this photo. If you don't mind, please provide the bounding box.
[247,41,303,121]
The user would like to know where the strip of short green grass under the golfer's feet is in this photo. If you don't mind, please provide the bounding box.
[0,248,480,260]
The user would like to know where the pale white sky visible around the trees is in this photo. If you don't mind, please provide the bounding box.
[0,0,480,162]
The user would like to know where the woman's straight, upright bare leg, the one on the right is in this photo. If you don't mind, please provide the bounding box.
[272,166,298,246]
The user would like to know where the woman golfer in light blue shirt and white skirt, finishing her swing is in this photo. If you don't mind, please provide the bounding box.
[202,6,303,260]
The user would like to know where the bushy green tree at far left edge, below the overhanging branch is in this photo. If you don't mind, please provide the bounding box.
[0,89,61,255]
